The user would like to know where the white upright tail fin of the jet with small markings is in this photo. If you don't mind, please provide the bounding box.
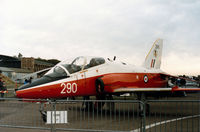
[144,39,163,69]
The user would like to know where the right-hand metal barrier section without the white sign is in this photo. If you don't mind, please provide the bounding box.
[145,100,200,132]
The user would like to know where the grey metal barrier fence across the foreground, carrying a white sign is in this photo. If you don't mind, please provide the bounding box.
[0,98,200,132]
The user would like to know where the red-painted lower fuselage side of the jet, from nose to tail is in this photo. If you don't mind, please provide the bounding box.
[16,73,167,99]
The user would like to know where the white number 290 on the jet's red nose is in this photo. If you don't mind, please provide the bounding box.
[60,83,77,94]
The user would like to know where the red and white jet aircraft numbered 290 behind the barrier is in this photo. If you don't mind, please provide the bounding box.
[16,39,200,99]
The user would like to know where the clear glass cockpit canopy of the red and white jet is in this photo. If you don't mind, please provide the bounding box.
[45,56,105,77]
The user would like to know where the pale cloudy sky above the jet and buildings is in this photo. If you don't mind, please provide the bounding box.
[0,0,200,75]
